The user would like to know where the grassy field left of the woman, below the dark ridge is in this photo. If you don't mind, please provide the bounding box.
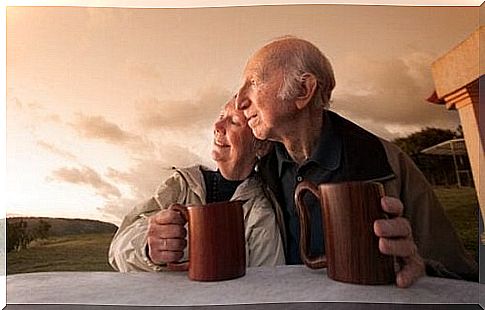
[7,233,113,275]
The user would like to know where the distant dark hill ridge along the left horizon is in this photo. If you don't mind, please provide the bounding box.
[7,217,117,237]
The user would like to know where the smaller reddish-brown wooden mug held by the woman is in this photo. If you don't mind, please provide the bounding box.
[167,200,246,281]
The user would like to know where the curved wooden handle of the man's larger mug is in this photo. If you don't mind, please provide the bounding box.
[295,181,327,269]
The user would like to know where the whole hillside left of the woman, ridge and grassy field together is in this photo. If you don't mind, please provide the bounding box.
[6,217,117,274]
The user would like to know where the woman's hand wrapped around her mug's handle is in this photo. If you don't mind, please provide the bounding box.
[147,208,187,264]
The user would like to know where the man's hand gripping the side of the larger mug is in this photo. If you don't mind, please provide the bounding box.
[374,197,425,288]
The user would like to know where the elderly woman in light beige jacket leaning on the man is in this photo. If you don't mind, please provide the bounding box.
[109,100,285,272]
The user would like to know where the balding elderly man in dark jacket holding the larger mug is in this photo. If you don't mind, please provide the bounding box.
[236,37,478,287]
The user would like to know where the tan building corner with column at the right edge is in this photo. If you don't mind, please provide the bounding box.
[428,26,485,244]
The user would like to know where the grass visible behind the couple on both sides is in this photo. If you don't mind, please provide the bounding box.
[7,187,478,274]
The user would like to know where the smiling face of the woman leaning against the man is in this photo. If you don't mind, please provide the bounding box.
[212,100,256,180]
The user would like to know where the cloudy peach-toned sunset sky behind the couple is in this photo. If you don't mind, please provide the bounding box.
[6,5,479,224]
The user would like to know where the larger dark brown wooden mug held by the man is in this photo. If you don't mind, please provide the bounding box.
[295,181,395,284]
